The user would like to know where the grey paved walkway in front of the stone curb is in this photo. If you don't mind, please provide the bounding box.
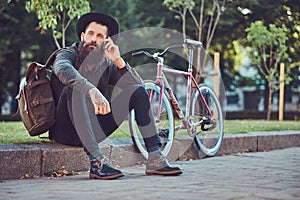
[0,147,300,200]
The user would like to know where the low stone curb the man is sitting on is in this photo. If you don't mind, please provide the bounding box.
[0,130,300,180]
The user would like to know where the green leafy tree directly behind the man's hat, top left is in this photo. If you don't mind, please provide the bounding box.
[26,0,90,48]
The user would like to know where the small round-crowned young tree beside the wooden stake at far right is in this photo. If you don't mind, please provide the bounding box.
[246,20,288,120]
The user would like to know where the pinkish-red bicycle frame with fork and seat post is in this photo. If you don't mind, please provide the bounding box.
[150,48,213,137]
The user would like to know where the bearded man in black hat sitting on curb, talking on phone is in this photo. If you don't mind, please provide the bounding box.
[50,13,182,179]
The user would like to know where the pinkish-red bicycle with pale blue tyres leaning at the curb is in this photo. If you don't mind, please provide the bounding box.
[129,39,224,158]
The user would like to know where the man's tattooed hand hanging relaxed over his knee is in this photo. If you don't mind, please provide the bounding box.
[89,88,111,115]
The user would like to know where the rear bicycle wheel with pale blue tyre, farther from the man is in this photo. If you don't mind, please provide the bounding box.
[189,84,224,156]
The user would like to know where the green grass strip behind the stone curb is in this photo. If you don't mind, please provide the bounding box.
[0,120,300,144]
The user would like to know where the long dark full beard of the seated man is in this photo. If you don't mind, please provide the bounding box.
[75,41,104,71]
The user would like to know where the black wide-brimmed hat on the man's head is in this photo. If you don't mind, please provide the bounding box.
[76,12,119,39]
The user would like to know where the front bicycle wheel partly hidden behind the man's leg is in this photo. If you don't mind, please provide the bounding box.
[129,81,174,159]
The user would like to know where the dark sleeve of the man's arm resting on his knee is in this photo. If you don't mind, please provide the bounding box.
[52,48,95,95]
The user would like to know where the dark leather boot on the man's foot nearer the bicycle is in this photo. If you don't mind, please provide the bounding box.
[146,152,182,176]
